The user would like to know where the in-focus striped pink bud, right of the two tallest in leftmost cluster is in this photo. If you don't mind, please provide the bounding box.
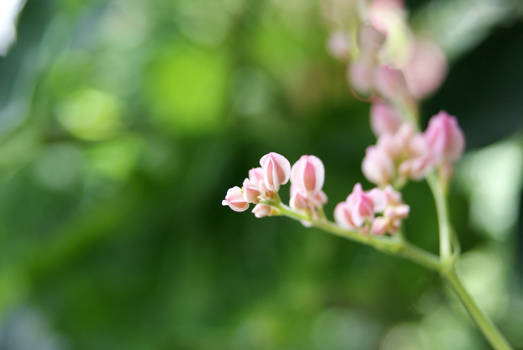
[291,155,325,193]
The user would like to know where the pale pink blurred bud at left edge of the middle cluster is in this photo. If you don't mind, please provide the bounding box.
[361,146,394,186]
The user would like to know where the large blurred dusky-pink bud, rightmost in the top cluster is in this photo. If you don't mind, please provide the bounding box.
[404,40,447,99]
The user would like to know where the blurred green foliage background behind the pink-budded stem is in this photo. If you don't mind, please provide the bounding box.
[0,0,523,350]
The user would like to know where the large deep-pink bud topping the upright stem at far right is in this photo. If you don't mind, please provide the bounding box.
[424,111,465,165]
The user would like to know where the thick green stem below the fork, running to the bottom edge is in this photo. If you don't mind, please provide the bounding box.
[442,268,512,350]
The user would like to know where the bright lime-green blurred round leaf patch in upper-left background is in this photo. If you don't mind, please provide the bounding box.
[145,43,228,134]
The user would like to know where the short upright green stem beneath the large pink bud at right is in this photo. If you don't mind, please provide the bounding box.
[427,174,452,262]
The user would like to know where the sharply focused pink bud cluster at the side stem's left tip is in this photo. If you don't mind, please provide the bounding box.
[222,152,327,218]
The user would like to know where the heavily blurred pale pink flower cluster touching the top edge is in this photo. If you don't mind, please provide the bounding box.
[323,0,447,102]
